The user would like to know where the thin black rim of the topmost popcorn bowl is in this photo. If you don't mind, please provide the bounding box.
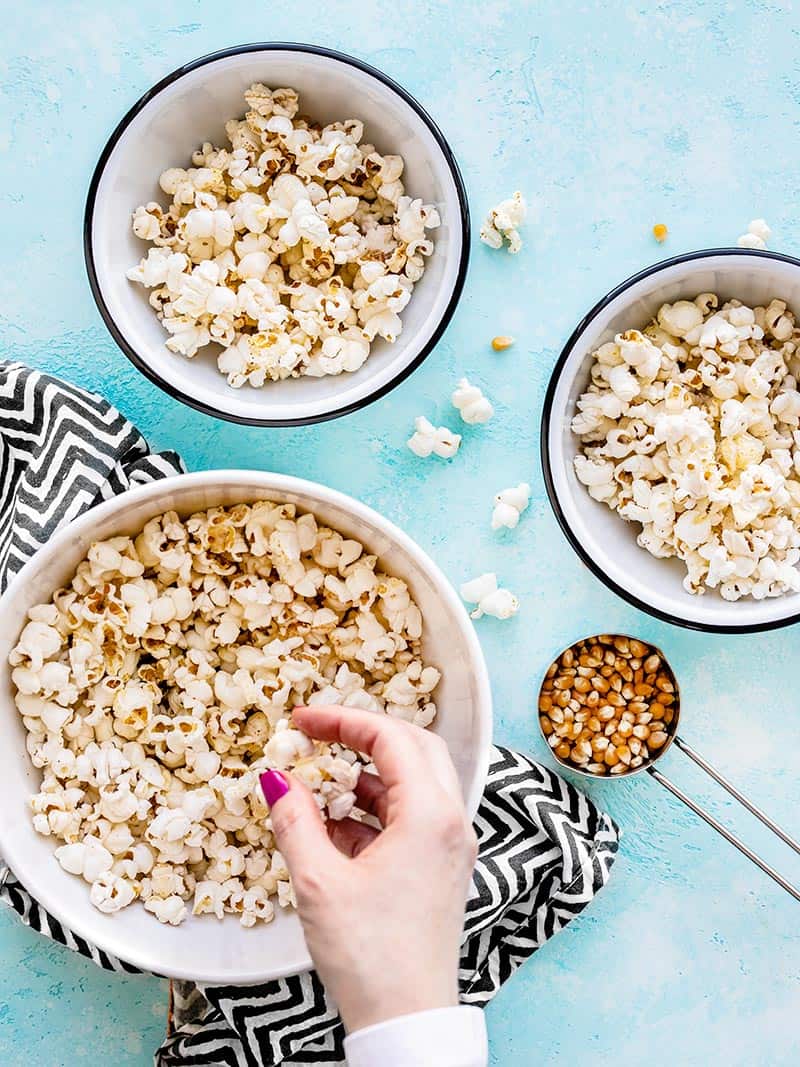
[83,42,470,427]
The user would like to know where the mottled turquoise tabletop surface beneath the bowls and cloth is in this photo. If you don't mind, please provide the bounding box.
[0,0,800,1067]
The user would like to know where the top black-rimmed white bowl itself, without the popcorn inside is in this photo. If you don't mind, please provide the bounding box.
[83,44,469,426]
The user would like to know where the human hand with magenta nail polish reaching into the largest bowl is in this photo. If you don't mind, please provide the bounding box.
[261,706,478,1032]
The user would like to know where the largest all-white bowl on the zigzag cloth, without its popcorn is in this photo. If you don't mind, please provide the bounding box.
[0,471,492,984]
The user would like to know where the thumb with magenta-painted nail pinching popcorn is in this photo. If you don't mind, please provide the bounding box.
[259,770,338,878]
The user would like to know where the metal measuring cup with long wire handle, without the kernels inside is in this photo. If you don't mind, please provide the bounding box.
[537,634,800,901]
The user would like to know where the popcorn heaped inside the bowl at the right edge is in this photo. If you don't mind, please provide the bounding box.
[572,296,800,600]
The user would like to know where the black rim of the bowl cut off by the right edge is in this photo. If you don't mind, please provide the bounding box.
[540,248,800,634]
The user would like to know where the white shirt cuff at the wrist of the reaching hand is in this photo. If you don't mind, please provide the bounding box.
[345,1005,489,1067]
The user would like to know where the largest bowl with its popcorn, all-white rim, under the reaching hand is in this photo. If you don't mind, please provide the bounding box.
[0,471,492,983]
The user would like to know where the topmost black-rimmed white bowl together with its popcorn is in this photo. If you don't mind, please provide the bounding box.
[84,44,469,426]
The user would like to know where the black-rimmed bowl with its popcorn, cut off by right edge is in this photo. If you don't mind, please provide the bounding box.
[542,249,800,633]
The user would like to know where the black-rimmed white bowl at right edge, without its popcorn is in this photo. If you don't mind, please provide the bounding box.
[542,249,800,633]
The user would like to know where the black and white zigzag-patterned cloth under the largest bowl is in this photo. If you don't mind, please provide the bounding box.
[0,362,619,1067]
